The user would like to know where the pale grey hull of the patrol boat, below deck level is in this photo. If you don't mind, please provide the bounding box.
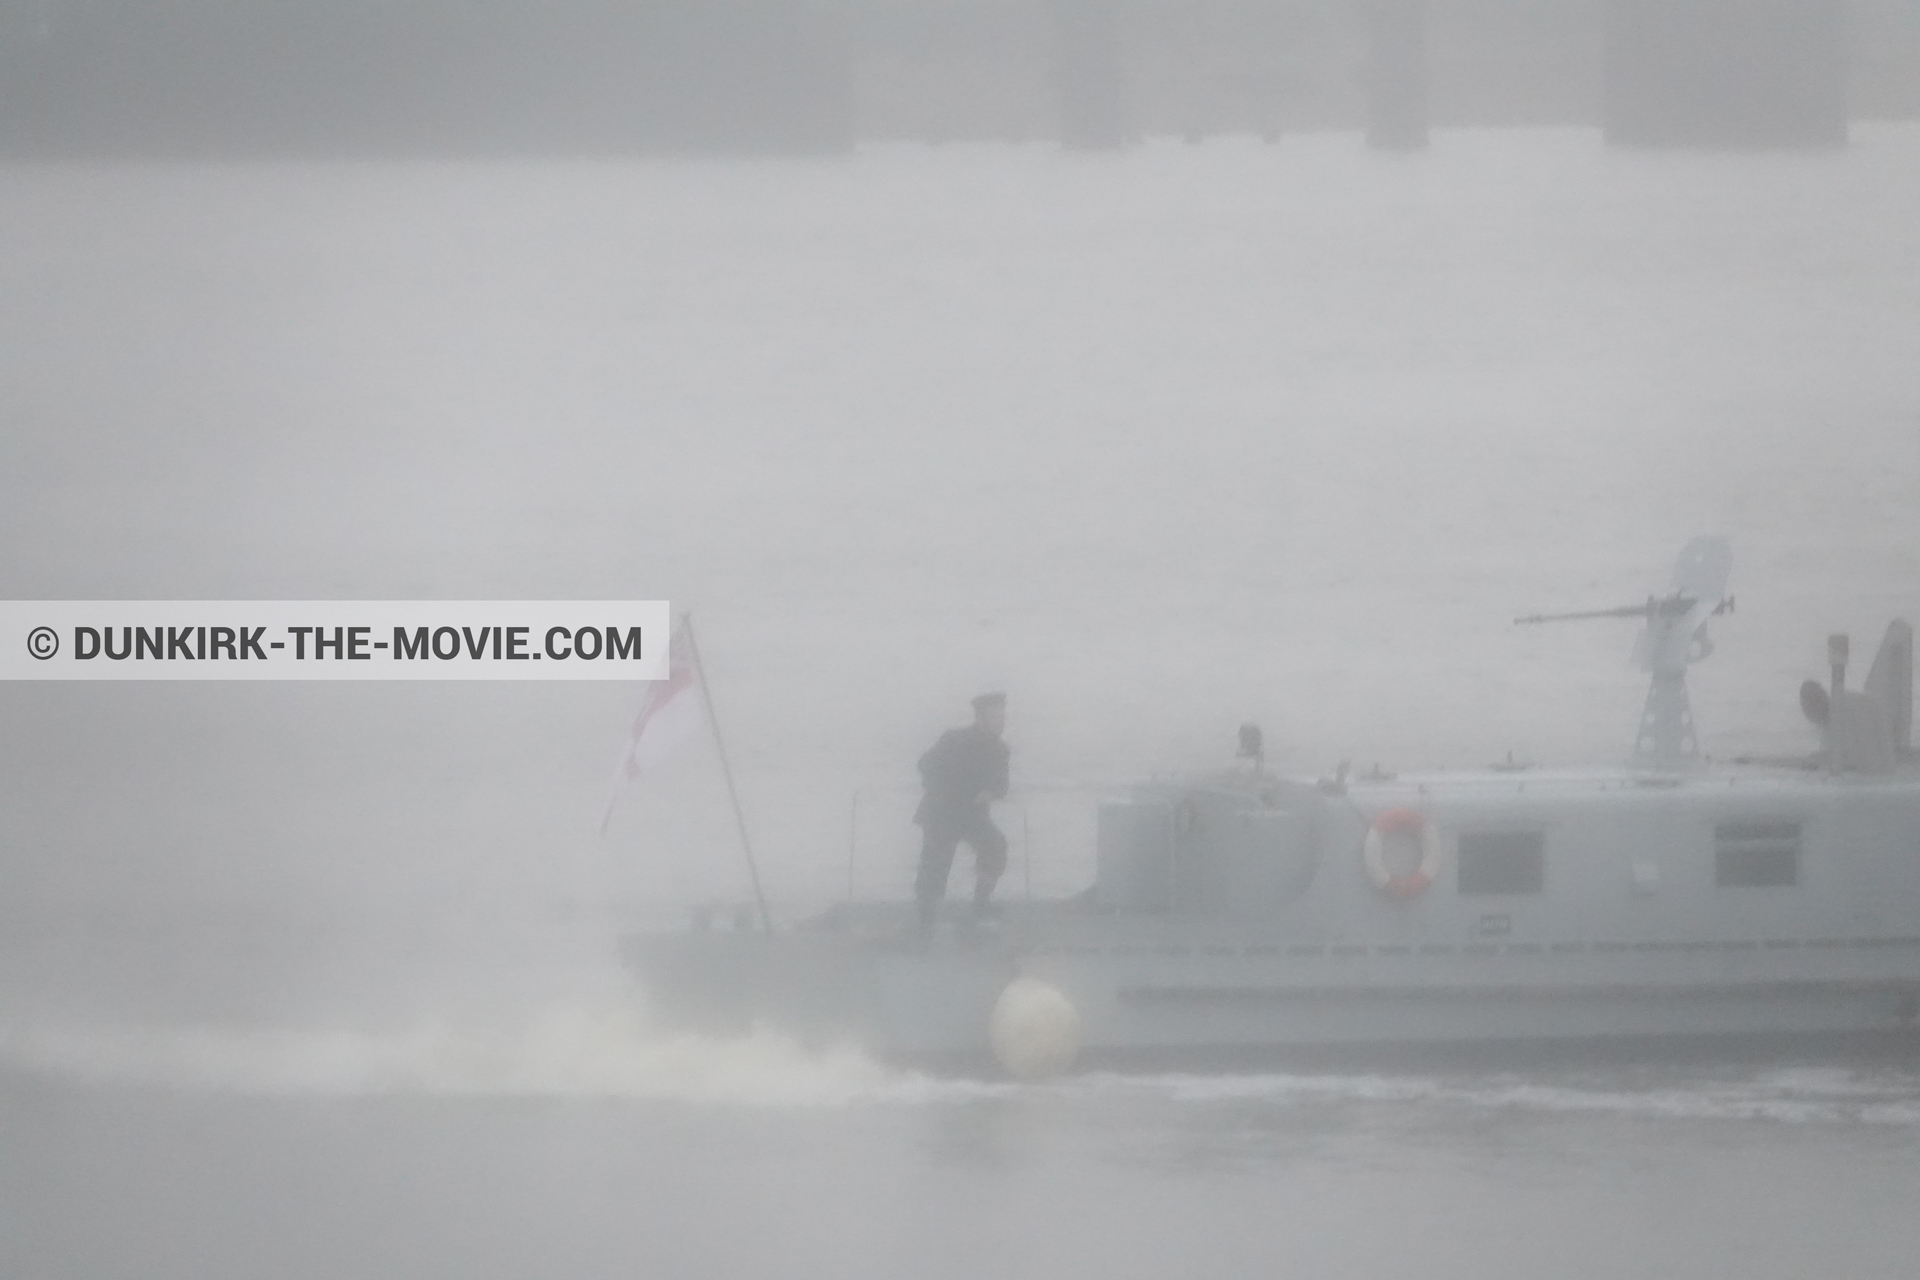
[626,912,1920,1063]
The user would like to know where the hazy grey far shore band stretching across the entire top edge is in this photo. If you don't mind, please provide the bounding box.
[0,0,1896,159]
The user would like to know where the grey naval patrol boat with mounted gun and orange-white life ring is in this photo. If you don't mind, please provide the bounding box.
[626,537,1920,1075]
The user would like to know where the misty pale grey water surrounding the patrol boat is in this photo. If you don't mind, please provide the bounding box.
[0,125,1920,1280]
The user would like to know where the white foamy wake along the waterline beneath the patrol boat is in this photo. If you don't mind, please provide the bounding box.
[0,1000,1920,1128]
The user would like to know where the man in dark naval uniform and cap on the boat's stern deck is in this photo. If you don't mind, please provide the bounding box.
[914,693,1010,929]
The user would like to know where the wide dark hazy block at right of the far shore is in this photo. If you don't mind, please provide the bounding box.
[1605,0,1847,148]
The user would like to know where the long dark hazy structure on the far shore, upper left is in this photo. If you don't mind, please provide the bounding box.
[0,0,856,157]
